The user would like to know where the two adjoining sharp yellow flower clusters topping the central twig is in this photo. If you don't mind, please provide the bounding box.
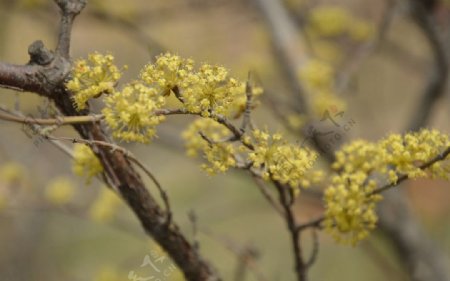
[141,53,245,116]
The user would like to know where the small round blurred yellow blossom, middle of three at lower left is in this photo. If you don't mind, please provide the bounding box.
[45,177,75,205]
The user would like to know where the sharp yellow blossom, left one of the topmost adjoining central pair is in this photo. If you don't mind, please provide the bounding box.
[141,53,194,95]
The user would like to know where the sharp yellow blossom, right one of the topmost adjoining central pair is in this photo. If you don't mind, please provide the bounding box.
[182,64,245,117]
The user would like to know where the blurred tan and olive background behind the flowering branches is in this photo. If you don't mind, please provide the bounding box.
[0,0,450,281]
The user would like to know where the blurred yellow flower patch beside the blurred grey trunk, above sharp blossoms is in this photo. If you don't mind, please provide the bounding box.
[299,59,345,116]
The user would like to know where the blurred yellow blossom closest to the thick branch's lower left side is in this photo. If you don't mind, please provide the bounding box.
[89,187,121,222]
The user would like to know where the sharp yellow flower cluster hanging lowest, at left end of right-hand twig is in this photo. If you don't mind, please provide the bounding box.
[324,172,381,245]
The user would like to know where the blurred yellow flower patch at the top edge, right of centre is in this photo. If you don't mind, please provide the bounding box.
[308,5,374,41]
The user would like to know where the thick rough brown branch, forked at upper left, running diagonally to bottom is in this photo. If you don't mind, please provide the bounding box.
[0,0,220,281]
